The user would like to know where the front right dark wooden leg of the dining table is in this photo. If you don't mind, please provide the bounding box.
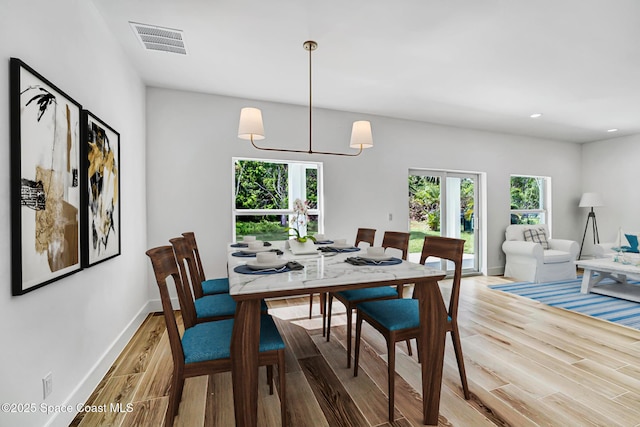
[414,280,447,425]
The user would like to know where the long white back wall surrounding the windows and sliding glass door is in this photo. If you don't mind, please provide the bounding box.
[147,88,582,286]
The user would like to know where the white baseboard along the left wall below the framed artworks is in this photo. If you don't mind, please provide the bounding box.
[45,300,154,427]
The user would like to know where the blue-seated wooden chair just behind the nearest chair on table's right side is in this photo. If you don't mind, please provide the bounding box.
[326,231,411,368]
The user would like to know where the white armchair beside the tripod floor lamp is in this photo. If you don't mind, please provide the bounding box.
[502,224,580,283]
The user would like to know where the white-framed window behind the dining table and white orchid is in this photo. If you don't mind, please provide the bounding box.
[232,158,322,241]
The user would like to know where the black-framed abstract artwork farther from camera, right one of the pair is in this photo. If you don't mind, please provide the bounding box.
[82,110,121,267]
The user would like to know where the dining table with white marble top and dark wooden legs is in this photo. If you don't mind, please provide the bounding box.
[227,242,447,427]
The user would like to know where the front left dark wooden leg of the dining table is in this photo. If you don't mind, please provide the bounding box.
[231,300,260,427]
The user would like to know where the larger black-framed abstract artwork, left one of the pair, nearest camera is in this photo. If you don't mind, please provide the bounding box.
[9,58,83,295]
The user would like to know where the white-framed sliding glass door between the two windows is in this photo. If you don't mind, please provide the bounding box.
[409,169,479,273]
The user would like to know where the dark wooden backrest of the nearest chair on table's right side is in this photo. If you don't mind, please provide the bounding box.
[420,236,465,321]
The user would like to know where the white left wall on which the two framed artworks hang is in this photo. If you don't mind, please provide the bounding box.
[0,0,149,426]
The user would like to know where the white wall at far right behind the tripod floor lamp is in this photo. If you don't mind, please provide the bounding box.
[579,135,640,254]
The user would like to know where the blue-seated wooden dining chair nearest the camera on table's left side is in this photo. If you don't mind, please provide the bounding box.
[146,246,286,426]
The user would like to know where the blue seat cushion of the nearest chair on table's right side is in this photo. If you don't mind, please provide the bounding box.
[358,298,451,331]
